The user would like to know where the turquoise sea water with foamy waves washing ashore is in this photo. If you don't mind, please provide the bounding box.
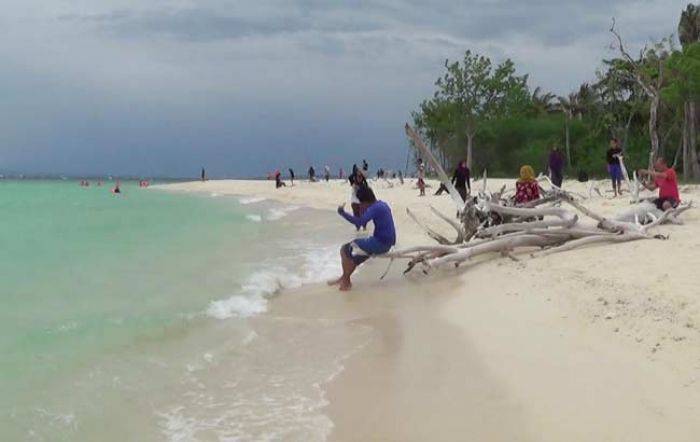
[0,181,368,441]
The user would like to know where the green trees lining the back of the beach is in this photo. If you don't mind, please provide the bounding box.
[412,4,700,180]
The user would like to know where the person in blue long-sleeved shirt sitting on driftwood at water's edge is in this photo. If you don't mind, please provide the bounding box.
[328,187,396,291]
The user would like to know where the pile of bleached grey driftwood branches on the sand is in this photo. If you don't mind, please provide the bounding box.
[382,125,692,273]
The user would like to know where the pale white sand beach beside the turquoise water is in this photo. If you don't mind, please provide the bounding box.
[161,179,700,441]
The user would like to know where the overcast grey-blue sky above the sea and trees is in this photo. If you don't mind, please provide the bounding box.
[0,0,687,176]
